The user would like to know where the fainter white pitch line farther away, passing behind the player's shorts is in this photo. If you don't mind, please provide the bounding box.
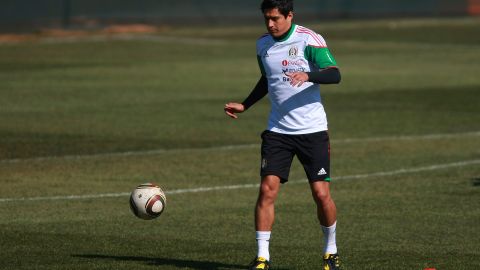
[0,131,480,164]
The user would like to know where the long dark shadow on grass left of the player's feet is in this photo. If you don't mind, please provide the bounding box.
[72,254,247,270]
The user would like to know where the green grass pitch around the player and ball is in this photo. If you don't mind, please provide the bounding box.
[0,18,480,270]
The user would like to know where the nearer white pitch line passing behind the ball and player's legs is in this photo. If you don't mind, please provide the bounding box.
[0,159,480,203]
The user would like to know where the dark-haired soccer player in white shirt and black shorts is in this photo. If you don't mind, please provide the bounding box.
[224,0,340,270]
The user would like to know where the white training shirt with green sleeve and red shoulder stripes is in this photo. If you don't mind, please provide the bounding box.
[257,24,337,134]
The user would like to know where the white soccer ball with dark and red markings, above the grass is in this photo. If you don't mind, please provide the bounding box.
[130,183,167,220]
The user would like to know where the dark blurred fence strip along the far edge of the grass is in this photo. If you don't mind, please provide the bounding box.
[0,0,480,31]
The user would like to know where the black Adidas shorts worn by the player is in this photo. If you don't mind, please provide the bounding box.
[260,130,330,183]
